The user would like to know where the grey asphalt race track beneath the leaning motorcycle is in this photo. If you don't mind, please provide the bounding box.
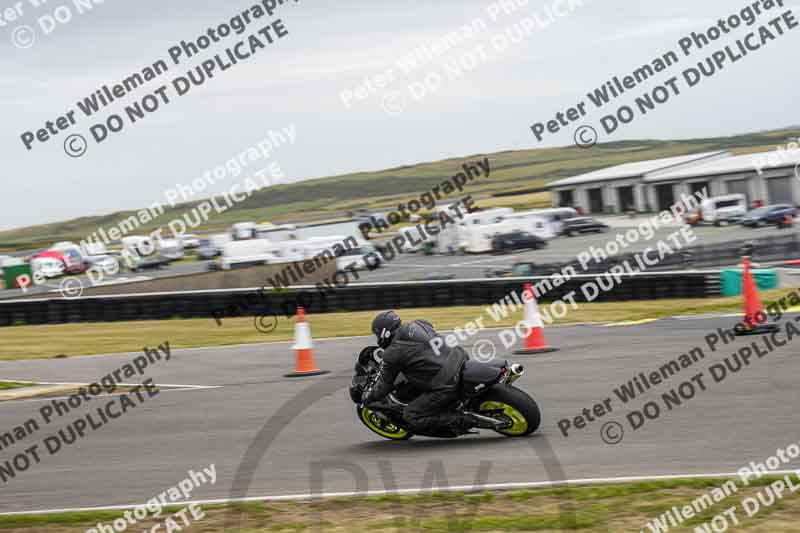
[0,317,800,512]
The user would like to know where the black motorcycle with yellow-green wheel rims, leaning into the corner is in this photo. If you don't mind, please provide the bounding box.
[350,346,541,440]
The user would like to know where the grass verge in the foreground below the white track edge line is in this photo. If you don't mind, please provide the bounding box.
[0,477,800,533]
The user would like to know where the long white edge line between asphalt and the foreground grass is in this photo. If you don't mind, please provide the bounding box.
[0,470,798,516]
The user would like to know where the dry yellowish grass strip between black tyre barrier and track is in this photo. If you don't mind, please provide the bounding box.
[0,289,790,360]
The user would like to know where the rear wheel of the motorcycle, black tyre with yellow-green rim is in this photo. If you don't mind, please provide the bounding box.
[478,385,542,437]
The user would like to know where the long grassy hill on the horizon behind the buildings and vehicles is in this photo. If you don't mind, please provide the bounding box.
[0,128,800,250]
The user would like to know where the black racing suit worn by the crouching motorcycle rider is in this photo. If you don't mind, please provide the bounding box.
[364,320,470,437]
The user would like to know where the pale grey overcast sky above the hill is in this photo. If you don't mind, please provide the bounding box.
[0,0,800,229]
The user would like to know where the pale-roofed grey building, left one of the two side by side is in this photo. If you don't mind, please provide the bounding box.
[547,151,730,213]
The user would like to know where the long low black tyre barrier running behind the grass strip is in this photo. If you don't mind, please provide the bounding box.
[0,271,721,327]
